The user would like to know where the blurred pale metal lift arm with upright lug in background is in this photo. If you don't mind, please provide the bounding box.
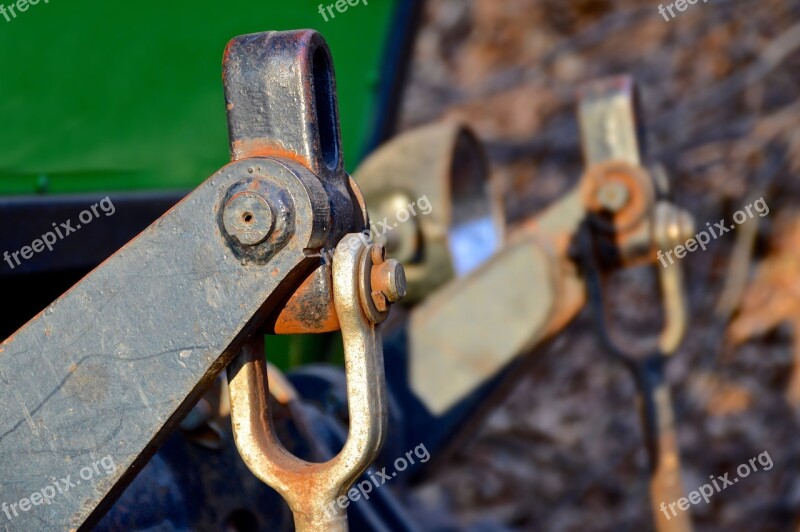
[409,78,672,415]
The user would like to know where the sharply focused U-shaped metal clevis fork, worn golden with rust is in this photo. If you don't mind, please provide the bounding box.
[228,234,388,532]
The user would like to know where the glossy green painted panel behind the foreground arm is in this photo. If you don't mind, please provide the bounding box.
[0,0,396,195]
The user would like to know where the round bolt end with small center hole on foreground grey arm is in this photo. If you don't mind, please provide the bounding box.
[222,191,275,246]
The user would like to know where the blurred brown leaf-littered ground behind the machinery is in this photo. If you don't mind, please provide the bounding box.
[400,0,800,530]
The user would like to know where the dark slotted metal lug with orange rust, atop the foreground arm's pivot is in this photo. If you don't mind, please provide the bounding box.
[224,30,367,334]
